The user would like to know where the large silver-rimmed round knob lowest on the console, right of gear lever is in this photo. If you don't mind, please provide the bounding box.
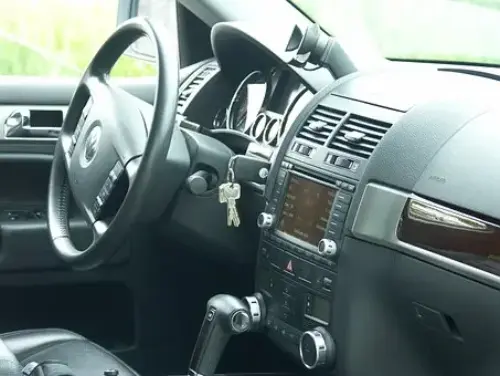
[299,327,335,369]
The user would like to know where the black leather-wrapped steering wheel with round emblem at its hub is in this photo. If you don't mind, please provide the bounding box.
[47,18,181,269]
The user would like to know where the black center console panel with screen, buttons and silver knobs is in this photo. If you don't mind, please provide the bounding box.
[256,162,356,369]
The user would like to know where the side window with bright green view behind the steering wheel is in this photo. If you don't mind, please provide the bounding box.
[0,0,155,77]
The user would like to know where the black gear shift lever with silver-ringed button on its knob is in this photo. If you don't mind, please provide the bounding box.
[189,294,252,376]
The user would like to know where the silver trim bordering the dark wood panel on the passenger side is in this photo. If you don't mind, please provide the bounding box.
[352,183,500,288]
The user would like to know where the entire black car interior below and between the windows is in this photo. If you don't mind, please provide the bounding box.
[0,0,500,376]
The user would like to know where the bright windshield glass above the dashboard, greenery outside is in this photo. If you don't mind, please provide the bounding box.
[291,0,500,65]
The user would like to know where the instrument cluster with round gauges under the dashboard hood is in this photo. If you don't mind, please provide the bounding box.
[213,68,307,146]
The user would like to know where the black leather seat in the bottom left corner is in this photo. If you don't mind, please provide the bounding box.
[0,329,138,376]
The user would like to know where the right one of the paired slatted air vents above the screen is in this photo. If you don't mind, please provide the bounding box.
[328,114,391,159]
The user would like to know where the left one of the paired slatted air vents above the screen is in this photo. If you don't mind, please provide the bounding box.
[297,104,346,145]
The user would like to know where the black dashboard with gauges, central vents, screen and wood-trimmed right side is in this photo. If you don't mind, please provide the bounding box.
[171,19,500,375]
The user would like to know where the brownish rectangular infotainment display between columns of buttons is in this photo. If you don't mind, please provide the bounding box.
[278,174,337,246]
